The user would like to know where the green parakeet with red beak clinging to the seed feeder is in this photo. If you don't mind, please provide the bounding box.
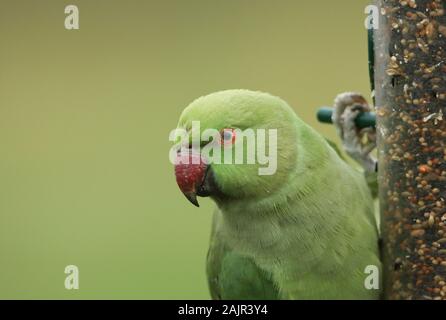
[175,90,381,300]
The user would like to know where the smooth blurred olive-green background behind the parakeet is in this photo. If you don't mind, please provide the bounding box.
[0,0,370,299]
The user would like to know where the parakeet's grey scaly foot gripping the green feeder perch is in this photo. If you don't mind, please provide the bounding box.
[332,92,377,172]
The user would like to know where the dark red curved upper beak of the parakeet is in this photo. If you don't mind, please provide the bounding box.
[175,150,207,207]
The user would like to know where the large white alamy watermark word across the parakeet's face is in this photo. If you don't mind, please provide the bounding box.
[169,121,277,176]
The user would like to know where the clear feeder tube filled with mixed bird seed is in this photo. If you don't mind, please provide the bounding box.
[374,0,446,300]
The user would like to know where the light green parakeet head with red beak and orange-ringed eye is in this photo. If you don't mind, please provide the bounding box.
[171,90,299,206]
